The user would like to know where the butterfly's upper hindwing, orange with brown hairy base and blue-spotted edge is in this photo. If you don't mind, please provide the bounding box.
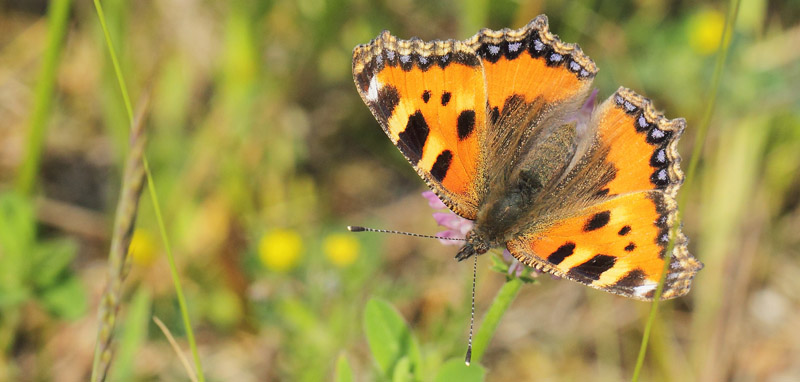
[468,15,597,181]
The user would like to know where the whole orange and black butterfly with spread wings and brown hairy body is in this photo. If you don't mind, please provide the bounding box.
[353,15,703,300]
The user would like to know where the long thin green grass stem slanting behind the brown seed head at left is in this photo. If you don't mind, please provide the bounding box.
[94,0,205,382]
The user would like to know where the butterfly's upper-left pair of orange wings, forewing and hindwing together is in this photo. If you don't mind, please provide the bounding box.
[353,15,597,220]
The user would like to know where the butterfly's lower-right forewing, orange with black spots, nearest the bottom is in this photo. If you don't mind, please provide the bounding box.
[508,191,702,300]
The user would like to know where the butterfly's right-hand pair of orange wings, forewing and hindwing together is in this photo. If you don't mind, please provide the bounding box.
[507,88,703,300]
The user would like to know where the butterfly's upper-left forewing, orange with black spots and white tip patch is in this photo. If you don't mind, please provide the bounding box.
[353,32,486,219]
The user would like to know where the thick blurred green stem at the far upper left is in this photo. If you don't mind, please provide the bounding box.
[16,0,70,195]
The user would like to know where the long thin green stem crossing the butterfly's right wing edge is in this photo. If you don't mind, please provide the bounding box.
[631,0,740,382]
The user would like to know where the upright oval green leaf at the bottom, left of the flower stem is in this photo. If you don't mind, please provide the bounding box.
[364,298,422,379]
